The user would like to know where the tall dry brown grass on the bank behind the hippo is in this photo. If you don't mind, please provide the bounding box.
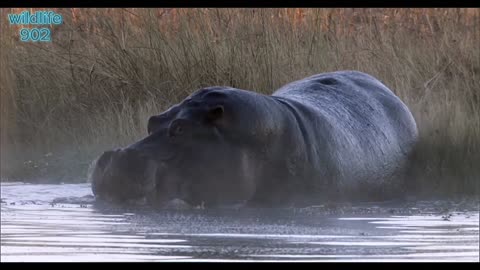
[0,9,480,194]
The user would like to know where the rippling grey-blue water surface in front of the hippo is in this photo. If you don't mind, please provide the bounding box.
[1,183,479,262]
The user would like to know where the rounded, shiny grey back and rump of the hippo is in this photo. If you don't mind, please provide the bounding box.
[272,71,417,198]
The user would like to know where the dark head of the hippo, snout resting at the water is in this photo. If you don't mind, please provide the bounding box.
[93,88,264,207]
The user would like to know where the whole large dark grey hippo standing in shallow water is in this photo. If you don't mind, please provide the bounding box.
[92,70,418,207]
